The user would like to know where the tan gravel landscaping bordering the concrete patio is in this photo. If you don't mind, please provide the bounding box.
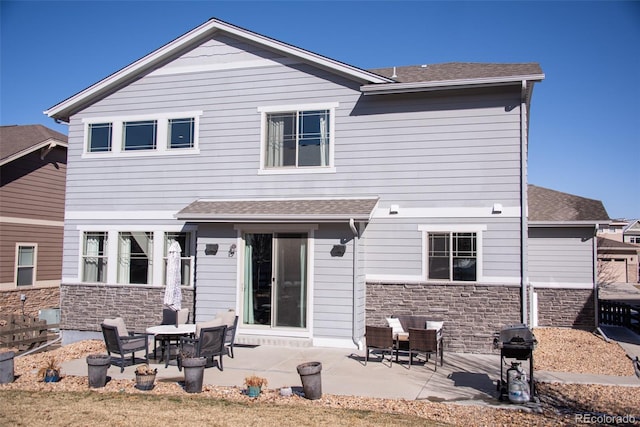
[0,328,640,426]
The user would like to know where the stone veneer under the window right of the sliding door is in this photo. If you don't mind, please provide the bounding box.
[366,283,521,358]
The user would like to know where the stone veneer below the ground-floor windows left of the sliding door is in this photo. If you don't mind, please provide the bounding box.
[60,284,194,332]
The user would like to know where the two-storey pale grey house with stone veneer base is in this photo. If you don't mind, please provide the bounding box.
[45,19,554,351]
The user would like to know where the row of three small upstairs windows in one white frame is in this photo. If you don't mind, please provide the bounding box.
[84,111,202,156]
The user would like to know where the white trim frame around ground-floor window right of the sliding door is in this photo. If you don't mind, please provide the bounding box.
[418,224,487,283]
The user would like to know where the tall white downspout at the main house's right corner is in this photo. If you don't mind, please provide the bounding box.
[520,80,533,325]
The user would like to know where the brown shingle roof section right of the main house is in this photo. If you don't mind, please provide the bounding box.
[528,185,609,222]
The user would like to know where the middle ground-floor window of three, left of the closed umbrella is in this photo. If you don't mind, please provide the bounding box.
[118,232,153,284]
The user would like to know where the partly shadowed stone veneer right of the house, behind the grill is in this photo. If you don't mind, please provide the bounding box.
[535,288,596,330]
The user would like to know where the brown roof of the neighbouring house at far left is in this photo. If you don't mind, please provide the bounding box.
[0,125,67,161]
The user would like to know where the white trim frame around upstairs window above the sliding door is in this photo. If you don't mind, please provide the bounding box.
[258,102,340,175]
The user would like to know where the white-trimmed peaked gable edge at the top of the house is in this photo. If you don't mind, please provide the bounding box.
[44,19,393,121]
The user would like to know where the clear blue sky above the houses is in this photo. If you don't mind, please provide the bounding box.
[0,0,640,218]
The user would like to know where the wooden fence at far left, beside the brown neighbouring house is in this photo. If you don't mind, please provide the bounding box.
[0,314,59,352]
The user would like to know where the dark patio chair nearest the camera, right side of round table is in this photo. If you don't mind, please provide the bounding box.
[178,325,227,371]
